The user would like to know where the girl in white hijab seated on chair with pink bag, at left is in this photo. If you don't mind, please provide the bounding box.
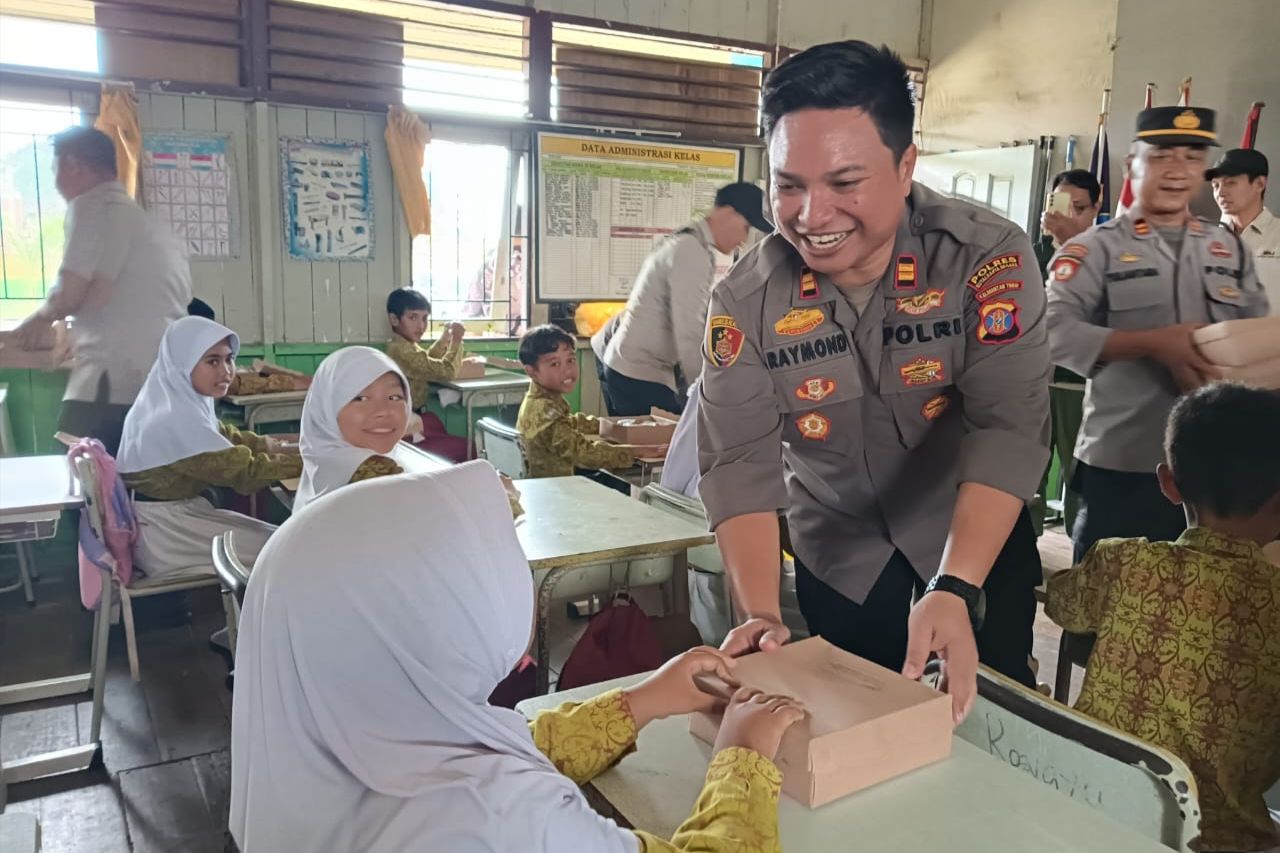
[116,316,302,578]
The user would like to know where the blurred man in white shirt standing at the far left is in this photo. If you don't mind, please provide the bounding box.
[14,127,191,455]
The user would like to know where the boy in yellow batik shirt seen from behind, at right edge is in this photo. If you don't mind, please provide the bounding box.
[1044,383,1280,852]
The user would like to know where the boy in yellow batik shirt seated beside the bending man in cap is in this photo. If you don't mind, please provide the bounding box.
[516,324,667,476]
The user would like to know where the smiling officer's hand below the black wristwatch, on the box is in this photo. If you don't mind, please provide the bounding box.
[901,593,978,725]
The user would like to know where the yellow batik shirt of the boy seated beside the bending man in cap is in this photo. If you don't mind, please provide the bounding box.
[516,384,635,476]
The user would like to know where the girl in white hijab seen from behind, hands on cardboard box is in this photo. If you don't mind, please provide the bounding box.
[230,462,803,853]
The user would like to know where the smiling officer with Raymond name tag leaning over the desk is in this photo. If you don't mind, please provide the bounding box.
[698,41,1050,716]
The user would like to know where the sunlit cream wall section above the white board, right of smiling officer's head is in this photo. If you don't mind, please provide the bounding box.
[920,0,1121,153]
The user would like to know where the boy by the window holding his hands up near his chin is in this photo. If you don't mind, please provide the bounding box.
[387,287,471,462]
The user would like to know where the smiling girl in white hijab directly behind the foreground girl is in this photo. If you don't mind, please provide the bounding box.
[293,347,413,512]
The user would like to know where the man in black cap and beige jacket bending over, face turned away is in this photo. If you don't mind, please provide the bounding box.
[591,182,773,415]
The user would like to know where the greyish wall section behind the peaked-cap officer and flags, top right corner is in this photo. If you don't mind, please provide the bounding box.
[1110,0,1280,215]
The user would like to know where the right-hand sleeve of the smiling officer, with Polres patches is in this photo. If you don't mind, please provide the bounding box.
[956,229,1050,501]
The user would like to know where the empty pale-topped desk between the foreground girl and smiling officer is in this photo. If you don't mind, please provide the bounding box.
[516,476,716,693]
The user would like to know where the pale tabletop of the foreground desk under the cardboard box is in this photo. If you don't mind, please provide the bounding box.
[516,675,1169,853]
